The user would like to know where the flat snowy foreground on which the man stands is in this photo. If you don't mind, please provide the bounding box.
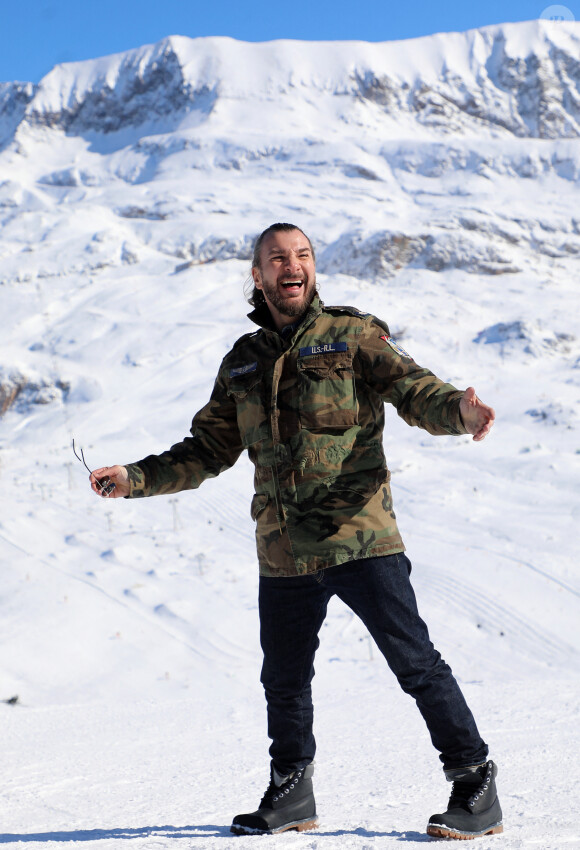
[0,672,578,850]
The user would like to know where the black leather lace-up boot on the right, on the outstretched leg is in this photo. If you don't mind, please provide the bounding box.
[427,761,503,839]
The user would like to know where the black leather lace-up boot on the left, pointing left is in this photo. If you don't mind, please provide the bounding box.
[230,764,318,835]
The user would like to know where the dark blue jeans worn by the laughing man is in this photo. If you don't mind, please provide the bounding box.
[260,554,488,775]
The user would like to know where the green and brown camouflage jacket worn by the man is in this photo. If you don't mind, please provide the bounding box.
[127,296,466,576]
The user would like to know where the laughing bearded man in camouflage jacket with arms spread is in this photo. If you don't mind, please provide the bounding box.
[91,224,502,839]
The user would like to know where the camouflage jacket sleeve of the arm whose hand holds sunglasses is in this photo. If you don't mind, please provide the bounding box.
[126,370,243,499]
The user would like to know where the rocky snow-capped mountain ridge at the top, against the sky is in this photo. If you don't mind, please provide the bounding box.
[0,21,580,144]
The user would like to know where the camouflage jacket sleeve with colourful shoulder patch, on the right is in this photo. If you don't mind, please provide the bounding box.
[359,319,467,436]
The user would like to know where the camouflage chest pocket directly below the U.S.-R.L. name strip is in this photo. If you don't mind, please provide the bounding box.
[298,351,358,431]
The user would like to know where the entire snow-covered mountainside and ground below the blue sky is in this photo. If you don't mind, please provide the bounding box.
[0,21,580,850]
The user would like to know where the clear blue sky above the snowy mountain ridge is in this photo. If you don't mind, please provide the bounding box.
[0,0,580,82]
